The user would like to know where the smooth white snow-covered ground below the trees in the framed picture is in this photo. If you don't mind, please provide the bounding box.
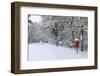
[28,43,88,61]
